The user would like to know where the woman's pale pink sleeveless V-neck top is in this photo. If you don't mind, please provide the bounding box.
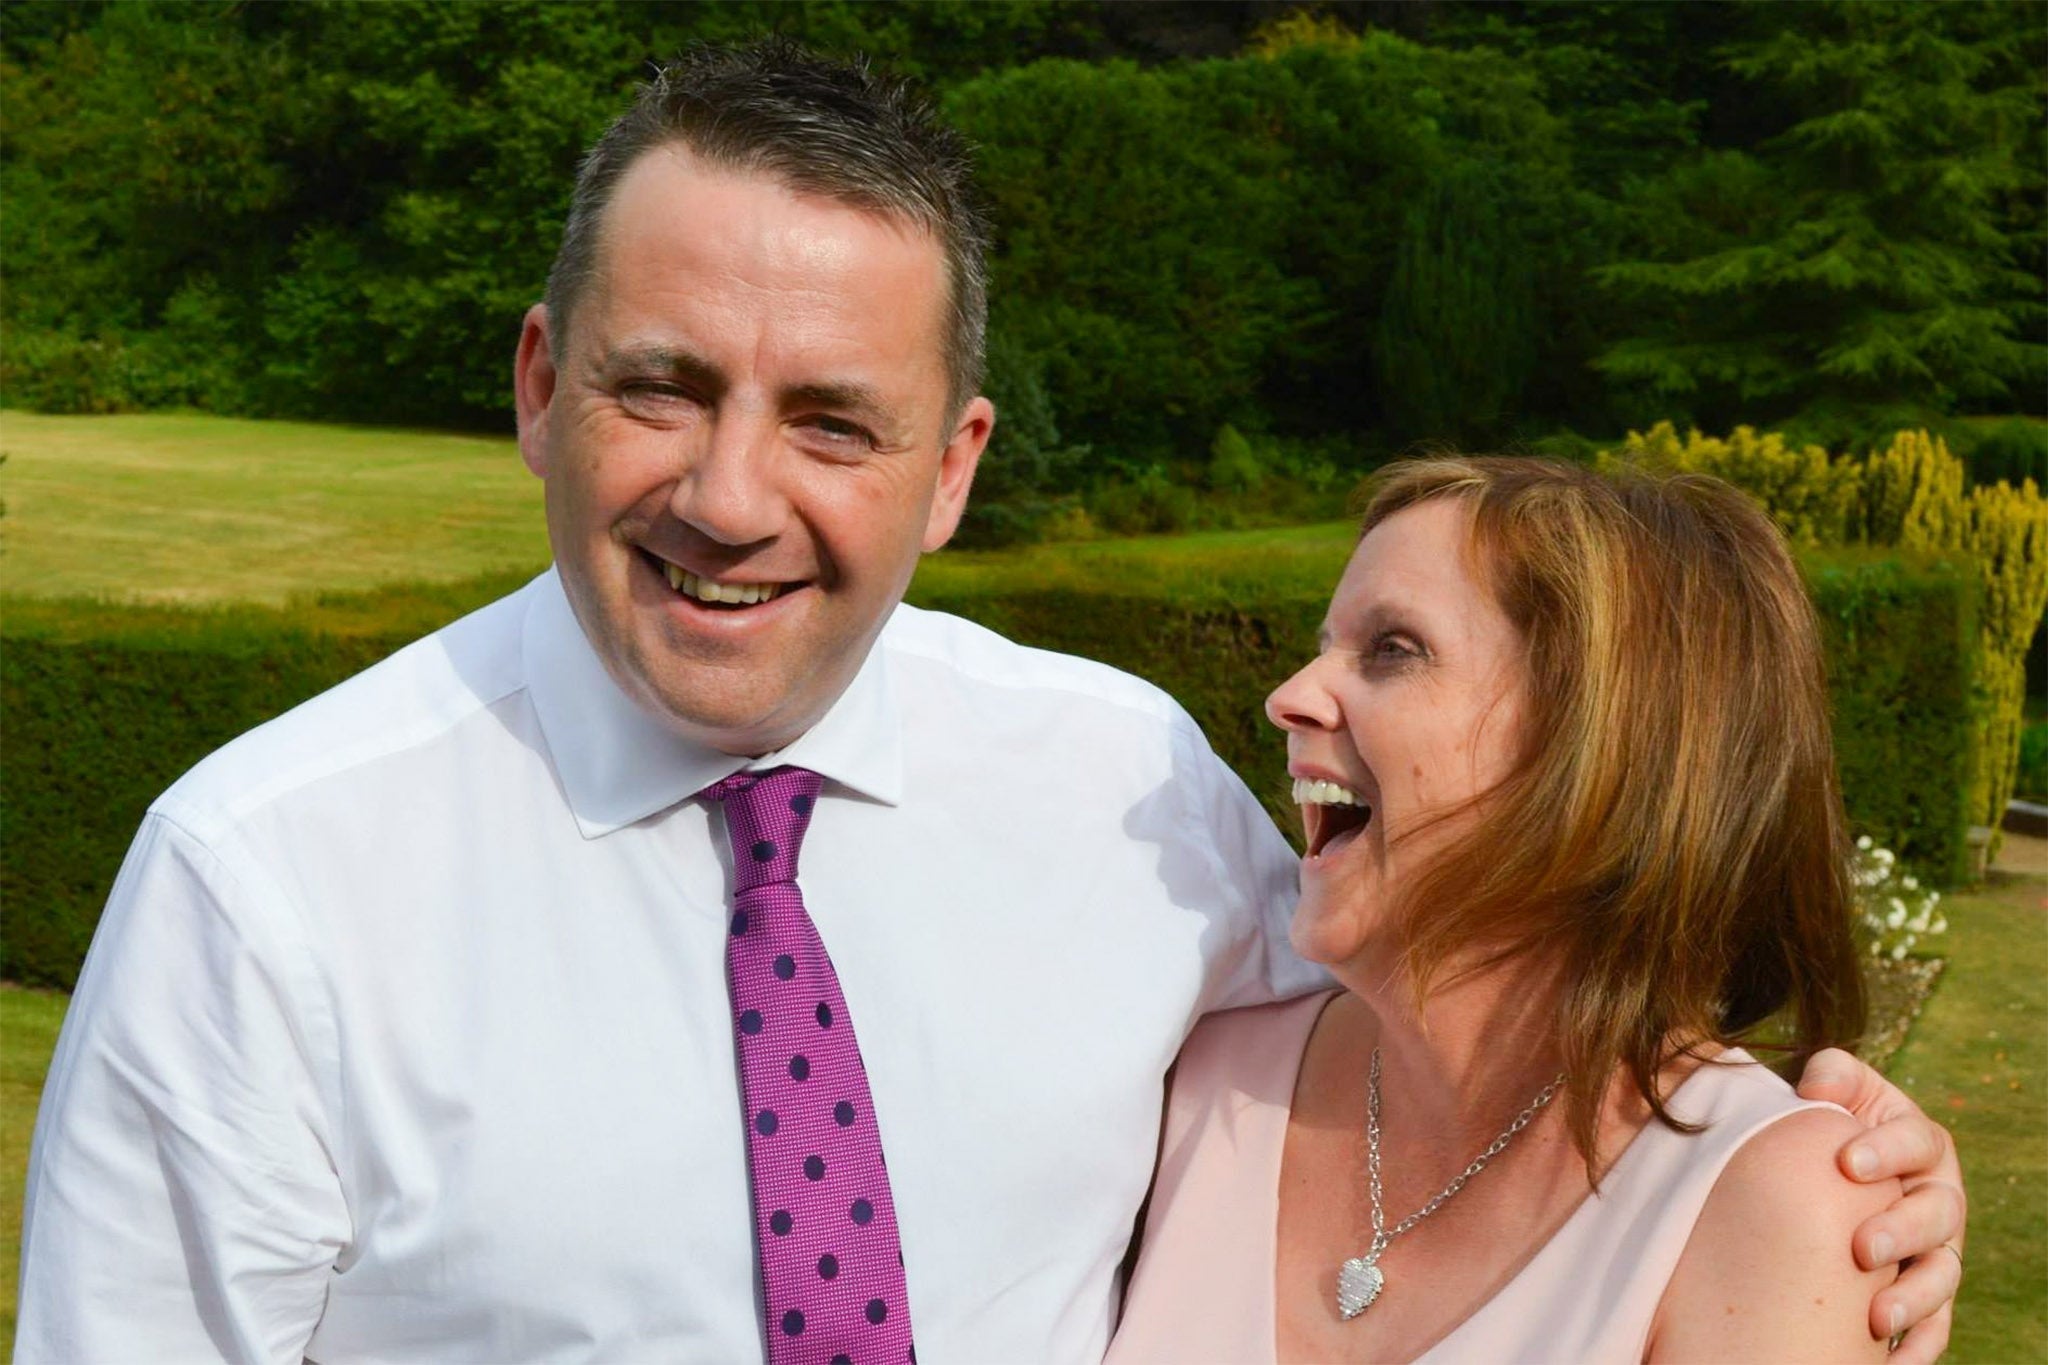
[1104,993,1817,1365]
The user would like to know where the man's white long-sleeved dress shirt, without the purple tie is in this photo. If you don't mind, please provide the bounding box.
[16,573,1321,1365]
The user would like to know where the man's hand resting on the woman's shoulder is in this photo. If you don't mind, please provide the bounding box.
[1798,1048,1966,1365]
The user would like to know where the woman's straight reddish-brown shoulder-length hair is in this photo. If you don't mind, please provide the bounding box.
[1362,458,1864,1179]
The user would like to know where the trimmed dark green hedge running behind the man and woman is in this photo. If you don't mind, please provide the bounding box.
[0,551,1974,986]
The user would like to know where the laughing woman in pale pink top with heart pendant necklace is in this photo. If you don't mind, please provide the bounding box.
[1110,458,1896,1365]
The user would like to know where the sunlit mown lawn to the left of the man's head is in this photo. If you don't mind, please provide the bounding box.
[0,409,547,606]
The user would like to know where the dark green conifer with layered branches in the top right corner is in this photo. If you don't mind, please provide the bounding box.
[1599,0,2048,440]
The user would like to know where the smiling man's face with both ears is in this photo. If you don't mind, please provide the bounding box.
[518,147,995,755]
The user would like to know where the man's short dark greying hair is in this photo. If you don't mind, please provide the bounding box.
[547,39,989,413]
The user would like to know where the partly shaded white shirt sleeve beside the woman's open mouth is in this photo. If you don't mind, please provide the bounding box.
[1174,716,1331,1013]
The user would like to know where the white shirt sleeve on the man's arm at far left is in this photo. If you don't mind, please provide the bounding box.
[14,812,348,1365]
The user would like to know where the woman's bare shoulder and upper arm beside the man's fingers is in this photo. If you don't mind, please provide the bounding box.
[1649,1107,1898,1361]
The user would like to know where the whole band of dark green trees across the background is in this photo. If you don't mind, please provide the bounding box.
[0,0,2048,511]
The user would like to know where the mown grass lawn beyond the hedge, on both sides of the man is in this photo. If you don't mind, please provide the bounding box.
[0,409,1352,606]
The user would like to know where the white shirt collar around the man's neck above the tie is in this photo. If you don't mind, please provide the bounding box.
[520,569,903,839]
